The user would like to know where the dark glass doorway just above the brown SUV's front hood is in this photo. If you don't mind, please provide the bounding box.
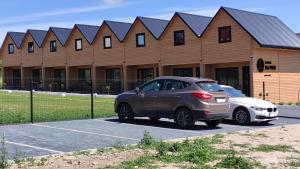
[106,68,122,94]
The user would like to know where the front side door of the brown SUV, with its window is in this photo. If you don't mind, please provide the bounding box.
[134,80,164,117]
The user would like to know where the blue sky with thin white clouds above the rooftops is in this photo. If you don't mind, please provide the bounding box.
[0,0,300,44]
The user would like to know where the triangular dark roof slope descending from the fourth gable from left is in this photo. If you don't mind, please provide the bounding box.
[74,24,100,44]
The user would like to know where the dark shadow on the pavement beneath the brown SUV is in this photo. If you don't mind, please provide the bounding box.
[105,119,222,131]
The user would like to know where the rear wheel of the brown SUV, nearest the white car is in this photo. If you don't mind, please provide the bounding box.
[175,108,195,129]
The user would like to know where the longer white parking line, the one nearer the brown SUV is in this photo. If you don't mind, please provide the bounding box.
[31,124,139,141]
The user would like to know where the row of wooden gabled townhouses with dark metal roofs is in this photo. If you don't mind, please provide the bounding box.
[0,7,300,102]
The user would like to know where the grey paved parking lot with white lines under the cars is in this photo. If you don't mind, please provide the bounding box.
[0,113,300,159]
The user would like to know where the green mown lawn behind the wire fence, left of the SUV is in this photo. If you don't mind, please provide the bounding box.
[0,91,115,124]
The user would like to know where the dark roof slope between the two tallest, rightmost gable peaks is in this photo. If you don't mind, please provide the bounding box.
[175,12,212,37]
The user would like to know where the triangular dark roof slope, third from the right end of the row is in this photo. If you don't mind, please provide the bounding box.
[137,16,169,39]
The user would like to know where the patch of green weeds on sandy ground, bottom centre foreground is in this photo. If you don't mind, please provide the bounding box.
[108,132,264,169]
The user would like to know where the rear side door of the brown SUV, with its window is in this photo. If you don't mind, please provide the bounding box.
[159,80,184,118]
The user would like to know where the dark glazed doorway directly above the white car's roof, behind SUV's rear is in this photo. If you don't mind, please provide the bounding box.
[216,67,239,89]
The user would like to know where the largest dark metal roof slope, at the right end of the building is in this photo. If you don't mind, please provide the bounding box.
[220,7,300,49]
